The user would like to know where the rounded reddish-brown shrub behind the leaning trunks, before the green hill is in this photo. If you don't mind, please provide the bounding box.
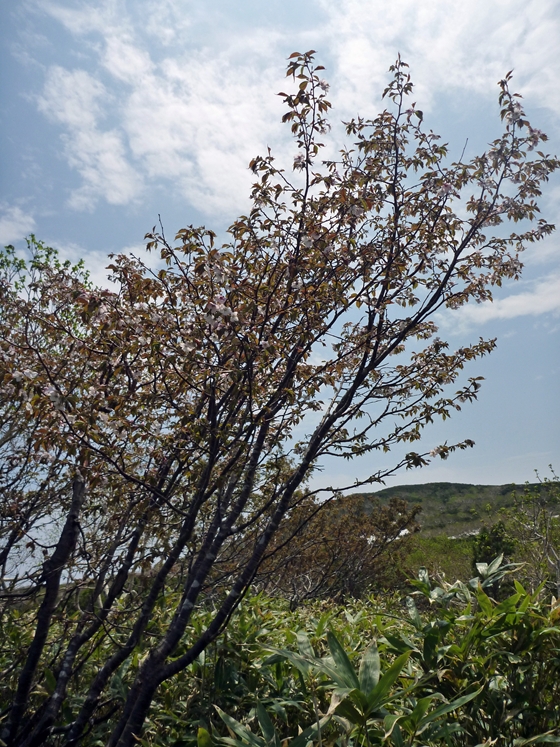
[256,495,421,607]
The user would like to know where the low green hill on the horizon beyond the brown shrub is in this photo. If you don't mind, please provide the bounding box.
[357,482,541,536]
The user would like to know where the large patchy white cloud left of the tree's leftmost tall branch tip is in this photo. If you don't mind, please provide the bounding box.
[35,3,294,214]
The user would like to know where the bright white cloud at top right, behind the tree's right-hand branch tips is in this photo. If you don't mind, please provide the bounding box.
[321,0,560,113]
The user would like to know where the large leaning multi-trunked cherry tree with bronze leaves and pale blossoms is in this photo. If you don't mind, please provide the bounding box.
[0,52,559,747]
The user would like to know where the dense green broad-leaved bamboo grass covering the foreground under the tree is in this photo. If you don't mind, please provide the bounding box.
[0,559,560,747]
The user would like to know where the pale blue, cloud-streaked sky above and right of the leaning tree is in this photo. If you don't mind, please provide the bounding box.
[0,0,560,485]
